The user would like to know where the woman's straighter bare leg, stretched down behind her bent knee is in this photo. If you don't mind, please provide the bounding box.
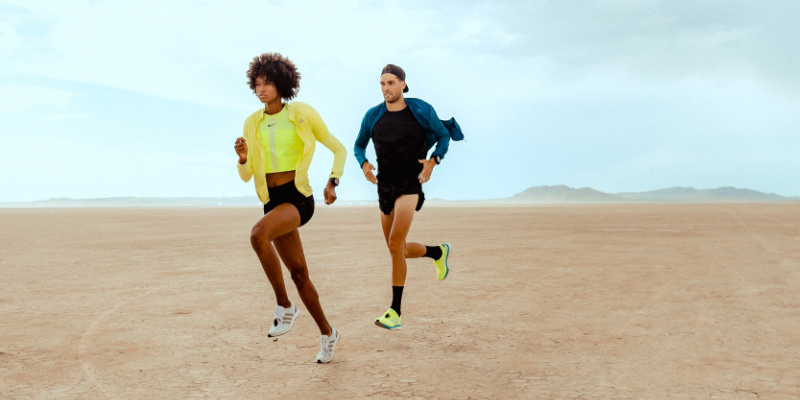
[274,230,332,336]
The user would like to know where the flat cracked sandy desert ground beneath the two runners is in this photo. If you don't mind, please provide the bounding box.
[0,204,800,399]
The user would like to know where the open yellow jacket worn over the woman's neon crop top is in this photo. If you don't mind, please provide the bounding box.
[236,101,347,204]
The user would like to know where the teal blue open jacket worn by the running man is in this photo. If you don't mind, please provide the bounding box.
[353,98,464,166]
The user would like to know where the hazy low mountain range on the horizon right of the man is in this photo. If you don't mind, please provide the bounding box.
[508,185,800,203]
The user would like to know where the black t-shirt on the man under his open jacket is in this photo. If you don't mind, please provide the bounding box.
[372,107,428,182]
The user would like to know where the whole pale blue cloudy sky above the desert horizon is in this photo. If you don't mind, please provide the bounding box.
[0,0,800,202]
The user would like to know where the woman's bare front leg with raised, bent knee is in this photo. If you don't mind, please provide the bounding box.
[250,203,300,308]
